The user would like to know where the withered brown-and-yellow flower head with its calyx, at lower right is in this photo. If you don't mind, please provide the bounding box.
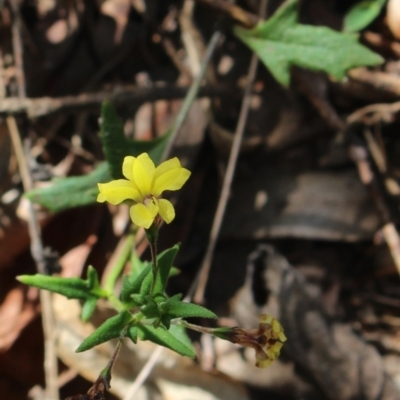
[213,314,286,368]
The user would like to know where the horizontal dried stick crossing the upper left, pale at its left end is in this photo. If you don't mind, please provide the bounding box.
[0,85,233,118]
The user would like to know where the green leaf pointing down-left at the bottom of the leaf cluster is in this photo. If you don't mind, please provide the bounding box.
[75,310,132,353]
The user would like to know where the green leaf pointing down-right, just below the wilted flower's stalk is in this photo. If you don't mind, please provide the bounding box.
[136,324,196,358]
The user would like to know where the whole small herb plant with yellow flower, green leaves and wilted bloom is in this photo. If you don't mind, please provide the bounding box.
[18,148,286,399]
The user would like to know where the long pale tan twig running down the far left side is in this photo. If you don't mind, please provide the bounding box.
[7,117,59,400]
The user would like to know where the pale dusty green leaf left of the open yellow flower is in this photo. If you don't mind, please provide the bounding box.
[25,162,112,212]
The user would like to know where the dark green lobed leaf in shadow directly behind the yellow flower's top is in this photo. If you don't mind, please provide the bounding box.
[100,101,170,179]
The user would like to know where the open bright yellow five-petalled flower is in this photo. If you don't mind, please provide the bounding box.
[97,153,190,229]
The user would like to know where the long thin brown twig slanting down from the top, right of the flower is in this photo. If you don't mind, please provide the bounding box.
[189,0,267,303]
